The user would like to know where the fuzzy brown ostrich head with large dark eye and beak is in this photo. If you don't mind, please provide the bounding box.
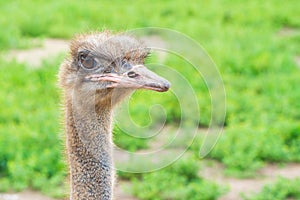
[59,32,170,109]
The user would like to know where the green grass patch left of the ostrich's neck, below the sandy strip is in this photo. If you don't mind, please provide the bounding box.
[0,59,66,196]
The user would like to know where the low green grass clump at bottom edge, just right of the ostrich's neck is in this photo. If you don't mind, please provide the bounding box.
[132,157,227,200]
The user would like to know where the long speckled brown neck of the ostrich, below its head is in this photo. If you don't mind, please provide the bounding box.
[66,97,114,200]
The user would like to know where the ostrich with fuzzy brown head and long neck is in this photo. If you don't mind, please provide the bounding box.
[59,31,170,200]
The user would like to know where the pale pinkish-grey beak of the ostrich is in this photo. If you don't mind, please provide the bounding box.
[86,65,171,92]
